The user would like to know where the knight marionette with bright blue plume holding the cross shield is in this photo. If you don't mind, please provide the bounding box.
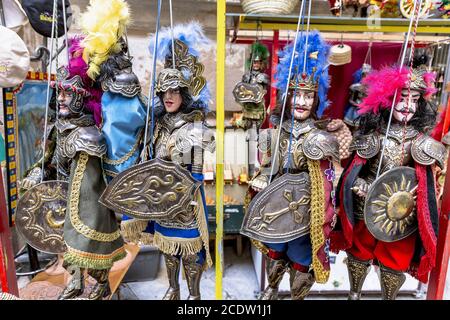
[241,32,339,299]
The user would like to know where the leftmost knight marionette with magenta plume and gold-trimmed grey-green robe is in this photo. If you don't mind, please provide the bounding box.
[20,38,126,300]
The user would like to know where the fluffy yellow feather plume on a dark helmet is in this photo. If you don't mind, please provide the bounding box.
[81,0,130,80]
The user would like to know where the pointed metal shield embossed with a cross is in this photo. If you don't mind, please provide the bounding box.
[241,172,311,243]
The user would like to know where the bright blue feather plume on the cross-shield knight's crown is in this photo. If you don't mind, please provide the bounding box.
[275,31,330,117]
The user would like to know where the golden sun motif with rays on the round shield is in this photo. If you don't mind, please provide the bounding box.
[372,174,417,236]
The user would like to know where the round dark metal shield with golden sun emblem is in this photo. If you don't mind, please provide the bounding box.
[364,167,417,242]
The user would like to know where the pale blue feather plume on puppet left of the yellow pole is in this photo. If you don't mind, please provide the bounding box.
[149,21,212,110]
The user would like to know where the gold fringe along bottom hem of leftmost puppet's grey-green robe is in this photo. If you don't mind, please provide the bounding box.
[64,244,127,270]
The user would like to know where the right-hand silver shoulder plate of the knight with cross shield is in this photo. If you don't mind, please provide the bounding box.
[303,129,339,162]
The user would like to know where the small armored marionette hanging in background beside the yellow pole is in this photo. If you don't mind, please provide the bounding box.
[233,42,270,130]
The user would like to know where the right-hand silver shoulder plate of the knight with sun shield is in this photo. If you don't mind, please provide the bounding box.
[411,136,446,169]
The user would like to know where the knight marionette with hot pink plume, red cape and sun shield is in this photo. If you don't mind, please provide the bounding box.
[331,54,445,300]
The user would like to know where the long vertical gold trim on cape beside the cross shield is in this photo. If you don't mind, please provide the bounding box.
[308,159,330,283]
